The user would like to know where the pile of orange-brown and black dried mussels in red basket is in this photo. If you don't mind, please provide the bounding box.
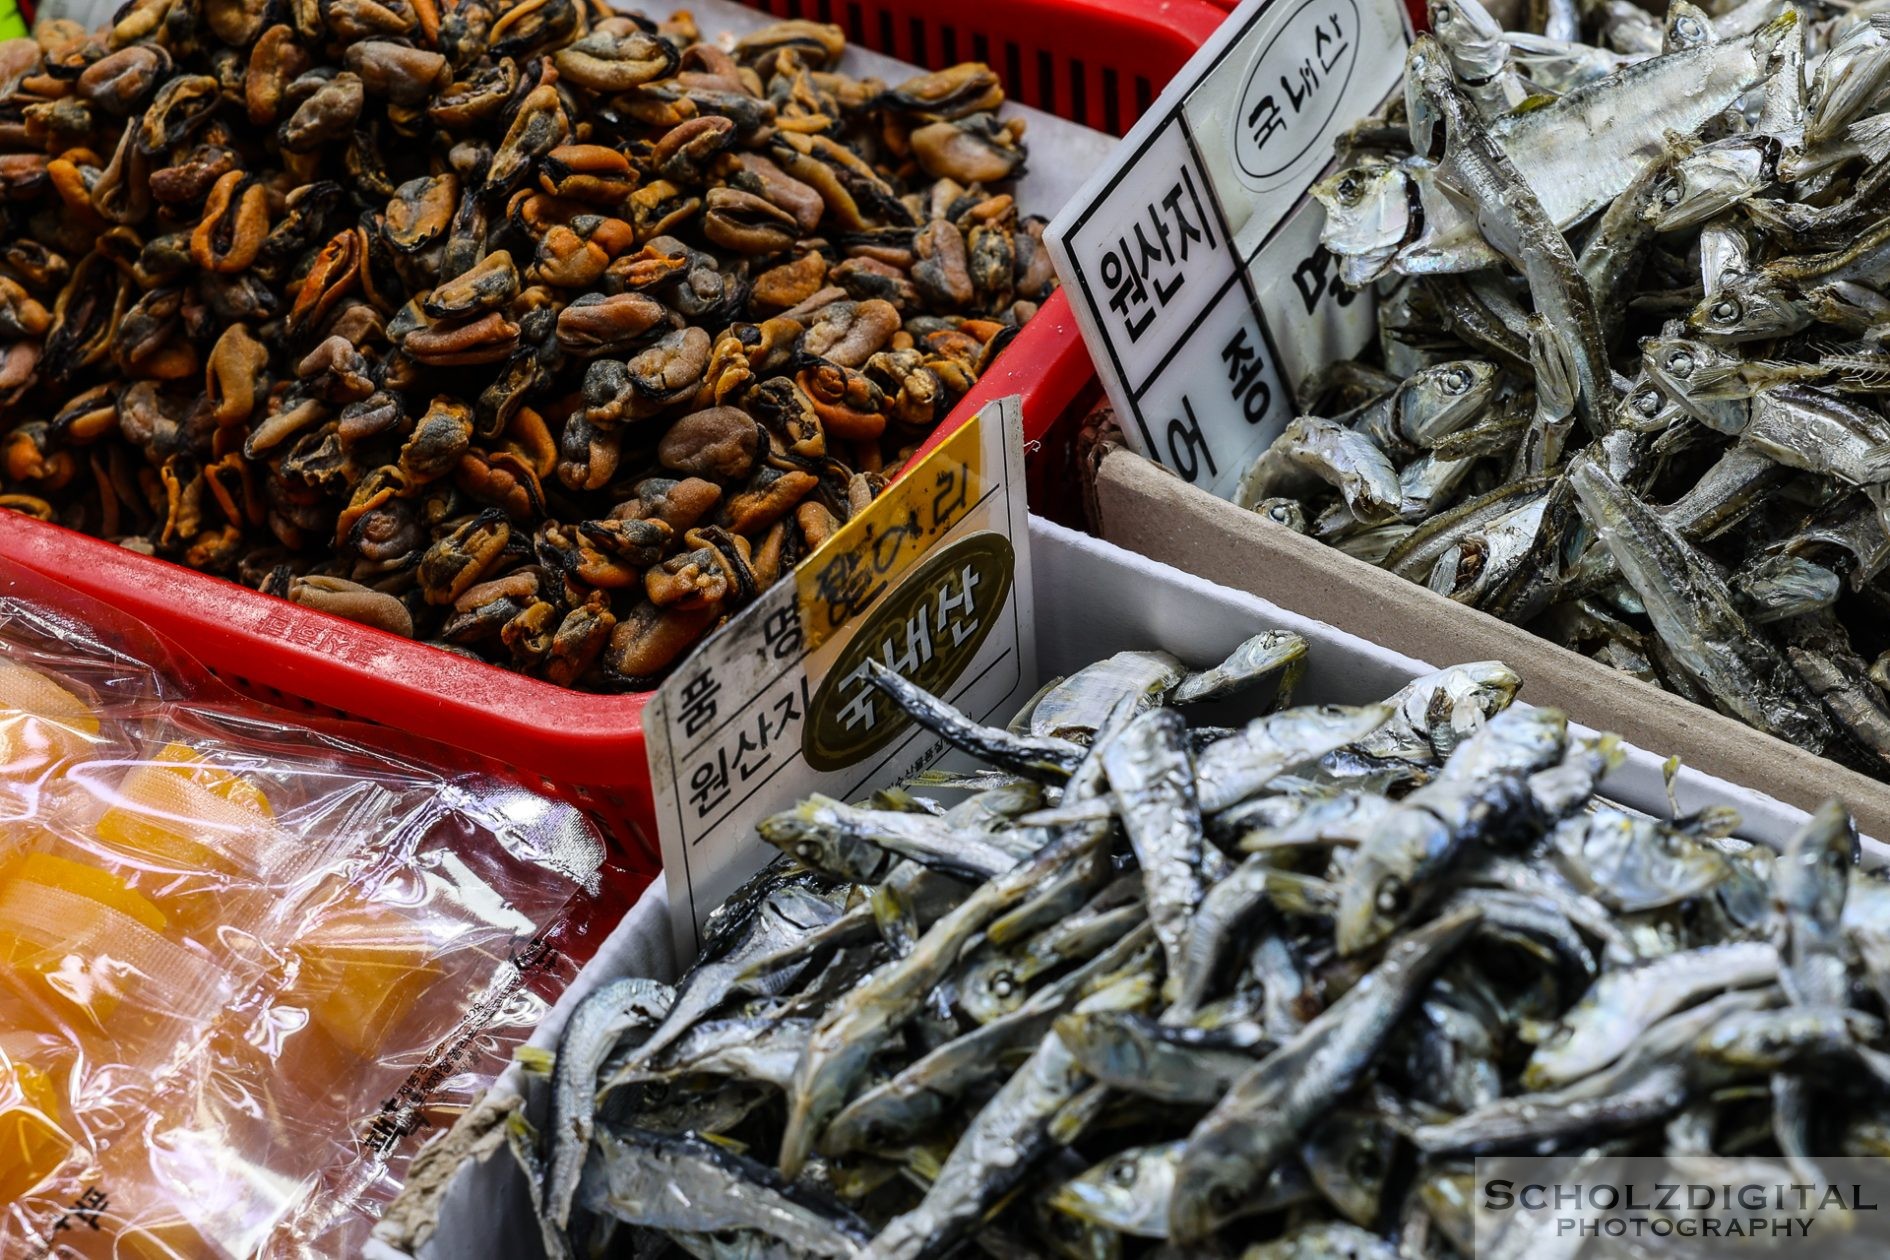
[0,0,1055,690]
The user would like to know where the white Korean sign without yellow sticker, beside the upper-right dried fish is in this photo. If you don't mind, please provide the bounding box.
[1045,0,1410,497]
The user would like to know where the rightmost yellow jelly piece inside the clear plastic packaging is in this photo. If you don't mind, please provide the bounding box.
[284,907,444,1058]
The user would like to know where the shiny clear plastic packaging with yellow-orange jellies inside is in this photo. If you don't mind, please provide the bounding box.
[0,561,605,1260]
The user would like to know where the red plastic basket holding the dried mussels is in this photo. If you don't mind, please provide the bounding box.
[0,0,1221,871]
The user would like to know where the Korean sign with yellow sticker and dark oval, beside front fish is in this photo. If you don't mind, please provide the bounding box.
[643,397,1036,958]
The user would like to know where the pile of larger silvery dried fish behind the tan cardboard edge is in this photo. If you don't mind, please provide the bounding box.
[1242,0,1890,776]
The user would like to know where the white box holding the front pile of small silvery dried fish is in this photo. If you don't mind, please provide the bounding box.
[369,517,1844,1260]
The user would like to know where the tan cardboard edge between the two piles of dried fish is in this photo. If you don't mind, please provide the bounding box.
[1094,448,1890,837]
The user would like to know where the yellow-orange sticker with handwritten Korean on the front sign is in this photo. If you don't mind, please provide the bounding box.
[794,416,990,648]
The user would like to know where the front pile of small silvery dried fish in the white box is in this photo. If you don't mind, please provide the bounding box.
[508,633,1890,1260]
